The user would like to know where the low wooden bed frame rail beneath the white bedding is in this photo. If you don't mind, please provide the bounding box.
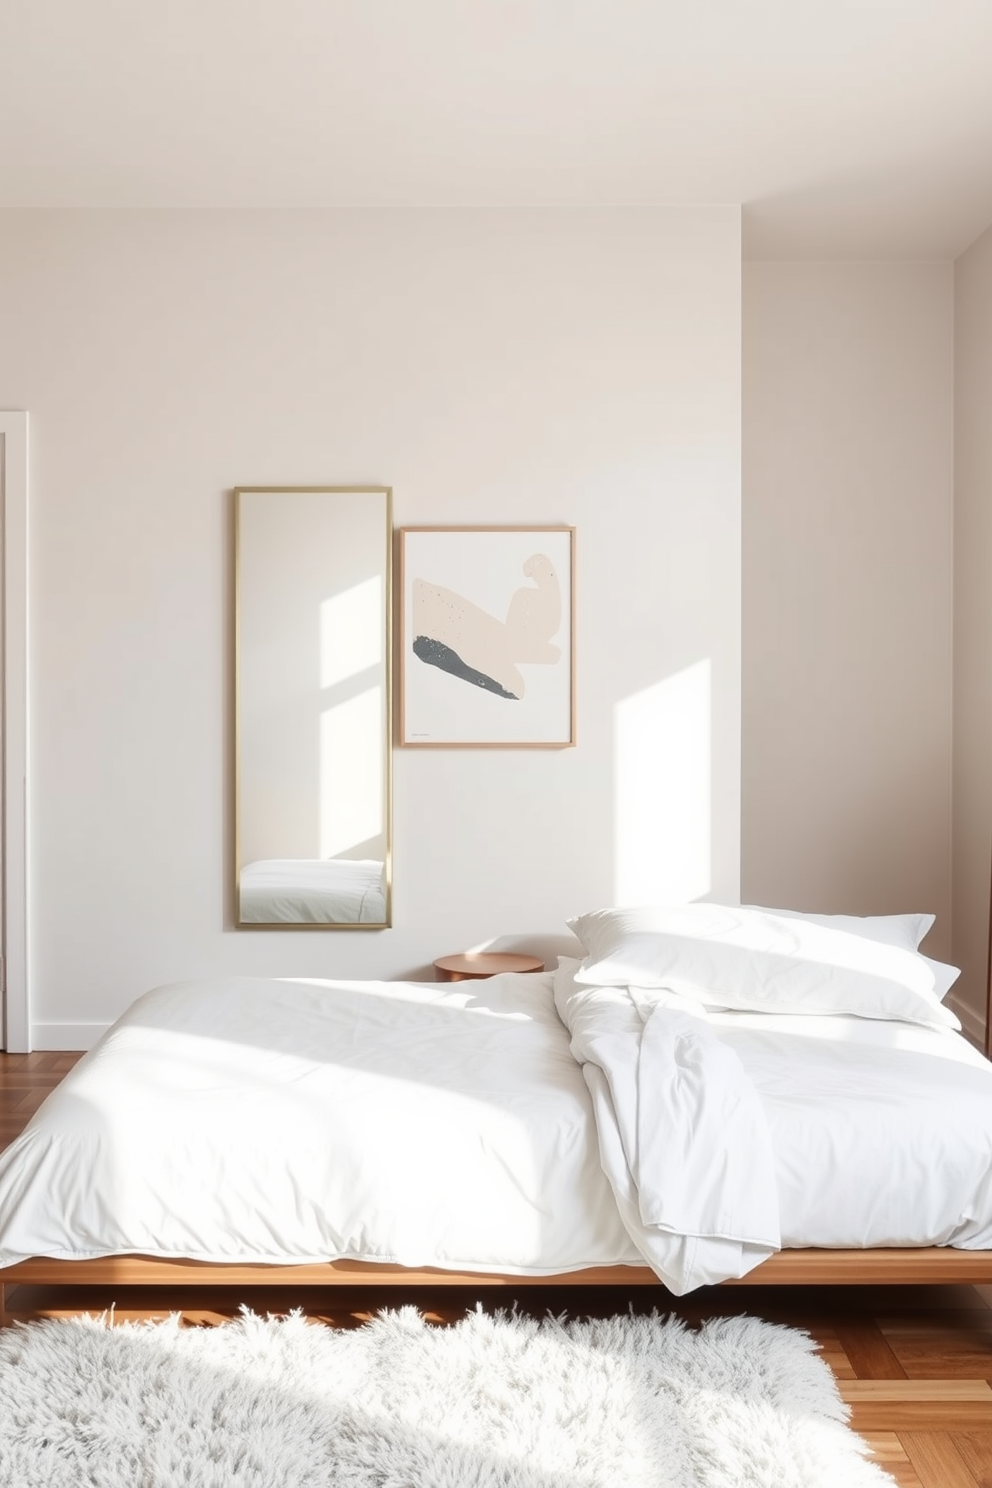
[7,1245,992,1327]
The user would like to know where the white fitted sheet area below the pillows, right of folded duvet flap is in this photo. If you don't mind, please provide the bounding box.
[711,1013,992,1250]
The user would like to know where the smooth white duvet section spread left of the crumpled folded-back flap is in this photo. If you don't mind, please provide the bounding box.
[0,975,640,1274]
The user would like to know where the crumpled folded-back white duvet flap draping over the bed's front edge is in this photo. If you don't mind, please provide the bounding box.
[555,970,781,1295]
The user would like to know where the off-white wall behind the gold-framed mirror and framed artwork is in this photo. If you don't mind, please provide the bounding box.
[0,207,740,1048]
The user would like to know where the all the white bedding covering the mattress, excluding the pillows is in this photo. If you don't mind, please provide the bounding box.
[0,972,992,1293]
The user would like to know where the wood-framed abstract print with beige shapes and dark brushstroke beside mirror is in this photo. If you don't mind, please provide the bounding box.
[399,527,576,748]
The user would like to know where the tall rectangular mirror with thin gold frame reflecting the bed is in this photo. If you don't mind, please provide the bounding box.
[235,487,393,930]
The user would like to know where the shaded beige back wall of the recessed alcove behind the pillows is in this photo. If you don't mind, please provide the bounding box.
[742,263,957,957]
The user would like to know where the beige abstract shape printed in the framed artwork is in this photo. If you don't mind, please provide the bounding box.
[412,554,562,698]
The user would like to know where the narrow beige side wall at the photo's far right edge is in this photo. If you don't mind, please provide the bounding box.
[953,229,992,1027]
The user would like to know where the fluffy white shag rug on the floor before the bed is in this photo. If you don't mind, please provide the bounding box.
[0,1308,892,1488]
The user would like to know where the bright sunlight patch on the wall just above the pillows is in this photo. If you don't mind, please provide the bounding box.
[613,659,712,905]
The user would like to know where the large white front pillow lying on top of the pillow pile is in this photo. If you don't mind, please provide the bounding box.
[568,905,961,1028]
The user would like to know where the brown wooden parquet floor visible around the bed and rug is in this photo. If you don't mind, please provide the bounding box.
[0,1054,992,1488]
